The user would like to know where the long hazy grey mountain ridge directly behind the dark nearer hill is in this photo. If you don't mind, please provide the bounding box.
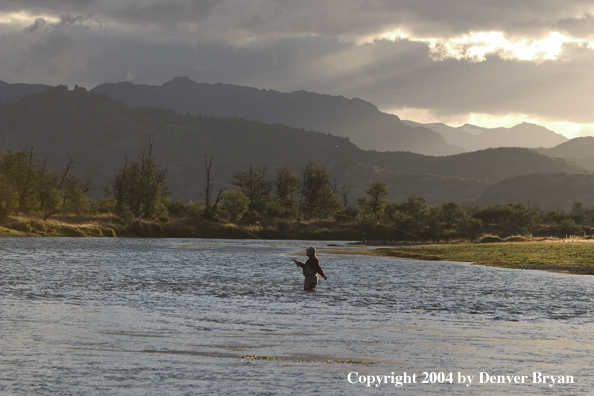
[91,77,463,155]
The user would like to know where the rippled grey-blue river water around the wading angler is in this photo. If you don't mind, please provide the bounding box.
[0,238,594,395]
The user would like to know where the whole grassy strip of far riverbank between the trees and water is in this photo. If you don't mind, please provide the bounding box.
[0,215,594,275]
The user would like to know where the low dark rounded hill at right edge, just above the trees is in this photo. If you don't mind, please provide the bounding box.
[477,173,594,211]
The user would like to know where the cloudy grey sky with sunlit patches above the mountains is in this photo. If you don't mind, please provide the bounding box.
[0,0,594,138]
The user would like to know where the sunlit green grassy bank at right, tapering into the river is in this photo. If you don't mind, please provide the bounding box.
[364,239,594,274]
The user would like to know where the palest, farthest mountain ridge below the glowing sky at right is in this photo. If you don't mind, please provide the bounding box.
[403,120,569,151]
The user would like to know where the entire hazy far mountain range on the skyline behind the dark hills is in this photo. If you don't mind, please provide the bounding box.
[0,77,568,155]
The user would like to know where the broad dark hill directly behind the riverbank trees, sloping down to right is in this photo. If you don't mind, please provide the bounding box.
[0,87,589,209]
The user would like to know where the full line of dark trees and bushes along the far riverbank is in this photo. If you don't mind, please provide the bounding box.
[0,145,594,240]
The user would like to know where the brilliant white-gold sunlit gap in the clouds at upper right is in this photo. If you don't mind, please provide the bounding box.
[378,30,594,62]
